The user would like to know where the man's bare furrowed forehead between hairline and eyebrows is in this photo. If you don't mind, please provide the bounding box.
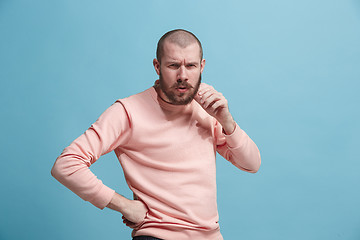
[162,41,201,62]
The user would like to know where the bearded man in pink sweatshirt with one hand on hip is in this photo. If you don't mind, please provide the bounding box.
[51,29,261,240]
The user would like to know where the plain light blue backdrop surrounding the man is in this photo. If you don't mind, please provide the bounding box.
[0,0,360,240]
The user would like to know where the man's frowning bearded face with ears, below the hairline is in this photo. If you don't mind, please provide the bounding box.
[154,42,205,105]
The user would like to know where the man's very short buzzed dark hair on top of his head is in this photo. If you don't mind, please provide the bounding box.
[156,29,203,62]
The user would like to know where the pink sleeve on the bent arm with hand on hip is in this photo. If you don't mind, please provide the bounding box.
[51,101,130,209]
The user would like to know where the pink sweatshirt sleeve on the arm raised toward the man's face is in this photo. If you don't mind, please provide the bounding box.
[215,122,261,173]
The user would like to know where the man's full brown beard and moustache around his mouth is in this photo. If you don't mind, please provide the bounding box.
[159,71,201,105]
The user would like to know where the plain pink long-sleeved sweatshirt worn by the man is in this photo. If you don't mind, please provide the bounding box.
[52,87,260,240]
